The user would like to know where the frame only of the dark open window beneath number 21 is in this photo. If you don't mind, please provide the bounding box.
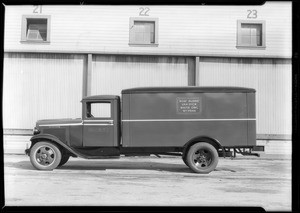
[21,15,51,43]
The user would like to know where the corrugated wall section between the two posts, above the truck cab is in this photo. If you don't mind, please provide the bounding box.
[91,55,188,95]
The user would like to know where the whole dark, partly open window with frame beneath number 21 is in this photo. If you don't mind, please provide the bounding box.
[21,15,50,43]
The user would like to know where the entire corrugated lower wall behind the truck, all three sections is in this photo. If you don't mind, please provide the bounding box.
[3,53,291,134]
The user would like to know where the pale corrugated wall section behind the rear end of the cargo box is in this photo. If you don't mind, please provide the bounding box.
[199,58,292,134]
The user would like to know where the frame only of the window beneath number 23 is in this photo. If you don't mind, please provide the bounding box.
[236,20,266,49]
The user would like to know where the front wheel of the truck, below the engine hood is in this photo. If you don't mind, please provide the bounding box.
[30,141,62,170]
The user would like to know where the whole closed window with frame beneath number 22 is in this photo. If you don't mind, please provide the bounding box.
[129,18,158,46]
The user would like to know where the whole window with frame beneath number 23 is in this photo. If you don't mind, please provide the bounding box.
[237,21,266,48]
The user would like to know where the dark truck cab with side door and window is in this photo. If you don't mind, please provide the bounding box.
[81,95,121,147]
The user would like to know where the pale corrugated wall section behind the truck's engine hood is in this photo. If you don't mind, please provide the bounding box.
[3,53,86,129]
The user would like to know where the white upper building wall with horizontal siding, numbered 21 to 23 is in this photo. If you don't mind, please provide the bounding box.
[4,2,292,58]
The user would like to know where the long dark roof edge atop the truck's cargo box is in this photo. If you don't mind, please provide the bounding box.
[122,86,255,94]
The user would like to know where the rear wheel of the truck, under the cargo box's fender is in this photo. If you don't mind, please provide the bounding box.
[186,142,219,174]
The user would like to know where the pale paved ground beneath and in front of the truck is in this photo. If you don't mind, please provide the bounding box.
[4,155,291,211]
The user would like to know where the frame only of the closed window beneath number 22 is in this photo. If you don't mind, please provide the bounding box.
[129,17,158,47]
